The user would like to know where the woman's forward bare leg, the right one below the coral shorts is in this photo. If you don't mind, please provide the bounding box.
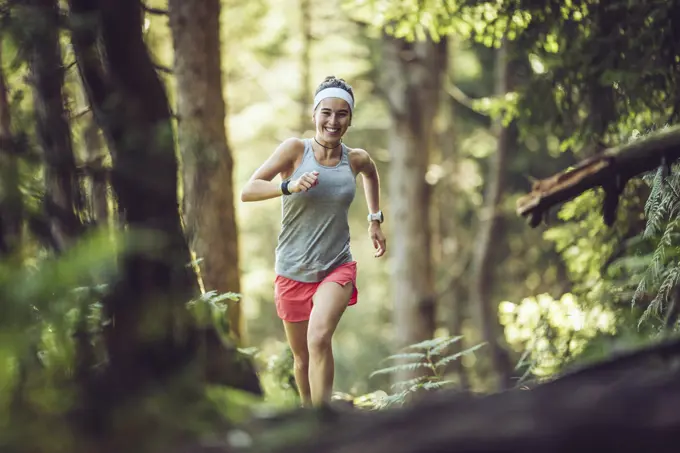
[307,282,352,406]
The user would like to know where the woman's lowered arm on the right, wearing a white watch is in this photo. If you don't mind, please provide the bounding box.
[352,149,387,258]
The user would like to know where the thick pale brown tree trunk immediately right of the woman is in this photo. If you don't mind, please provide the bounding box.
[383,35,446,381]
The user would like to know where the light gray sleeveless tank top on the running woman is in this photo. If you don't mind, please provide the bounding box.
[275,139,356,282]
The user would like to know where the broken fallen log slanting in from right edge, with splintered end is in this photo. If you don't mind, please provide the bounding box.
[516,126,680,227]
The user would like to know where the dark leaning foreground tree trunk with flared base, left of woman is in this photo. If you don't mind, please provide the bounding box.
[70,0,261,444]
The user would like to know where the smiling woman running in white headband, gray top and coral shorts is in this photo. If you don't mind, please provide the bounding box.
[241,76,386,407]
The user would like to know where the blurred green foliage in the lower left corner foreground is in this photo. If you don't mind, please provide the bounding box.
[0,234,117,451]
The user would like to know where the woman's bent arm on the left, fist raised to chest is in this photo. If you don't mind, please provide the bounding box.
[241,138,316,202]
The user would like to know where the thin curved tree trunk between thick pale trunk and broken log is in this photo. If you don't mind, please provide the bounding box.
[470,45,513,389]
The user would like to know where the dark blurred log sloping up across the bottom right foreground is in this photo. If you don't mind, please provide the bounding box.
[232,340,680,453]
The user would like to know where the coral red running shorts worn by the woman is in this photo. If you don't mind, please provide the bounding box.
[274,261,359,322]
